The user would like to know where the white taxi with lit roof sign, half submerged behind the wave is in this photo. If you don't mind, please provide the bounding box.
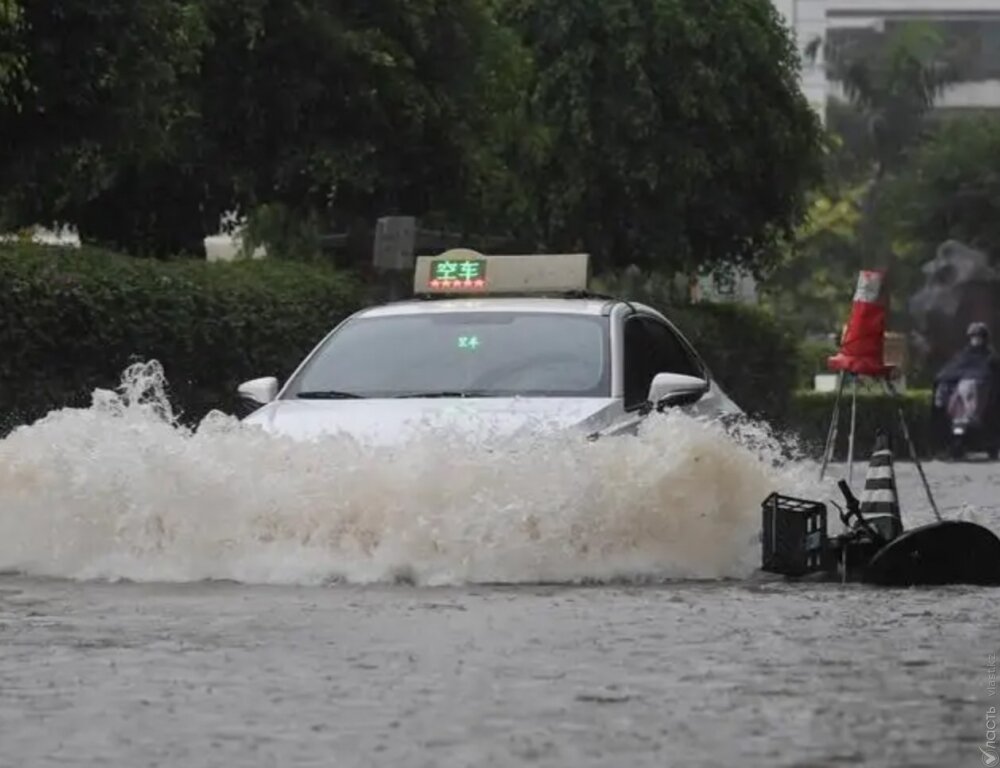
[239,249,742,444]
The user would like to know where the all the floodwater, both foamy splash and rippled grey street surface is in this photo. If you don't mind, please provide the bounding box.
[0,368,1000,768]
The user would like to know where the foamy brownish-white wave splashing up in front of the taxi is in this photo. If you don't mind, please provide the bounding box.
[0,363,817,585]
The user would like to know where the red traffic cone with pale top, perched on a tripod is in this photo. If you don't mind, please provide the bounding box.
[827,270,892,376]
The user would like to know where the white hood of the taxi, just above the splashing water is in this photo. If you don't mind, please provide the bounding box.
[243,397,620,445]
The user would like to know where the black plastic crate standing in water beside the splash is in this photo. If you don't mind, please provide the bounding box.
[761,493,827,576]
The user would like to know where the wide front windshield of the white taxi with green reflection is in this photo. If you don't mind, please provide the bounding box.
[284,311,611,399]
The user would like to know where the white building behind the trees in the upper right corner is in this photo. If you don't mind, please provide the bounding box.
[772,0,1000,114]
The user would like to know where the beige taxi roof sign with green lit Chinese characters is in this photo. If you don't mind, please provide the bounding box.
[413,248,590,296]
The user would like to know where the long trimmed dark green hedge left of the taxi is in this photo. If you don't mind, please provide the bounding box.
[0,244,360,434]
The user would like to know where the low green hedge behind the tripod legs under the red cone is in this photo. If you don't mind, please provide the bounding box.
[789,390,934,461]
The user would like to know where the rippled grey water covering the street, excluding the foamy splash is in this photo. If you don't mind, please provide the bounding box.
[0,450,1000,768]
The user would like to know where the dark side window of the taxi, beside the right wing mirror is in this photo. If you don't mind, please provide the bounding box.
[624,315,705,408]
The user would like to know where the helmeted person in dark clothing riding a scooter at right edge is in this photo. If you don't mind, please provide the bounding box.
[932,322,1000,453]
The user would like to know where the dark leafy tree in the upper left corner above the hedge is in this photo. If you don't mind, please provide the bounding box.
[0,0,218,251]
